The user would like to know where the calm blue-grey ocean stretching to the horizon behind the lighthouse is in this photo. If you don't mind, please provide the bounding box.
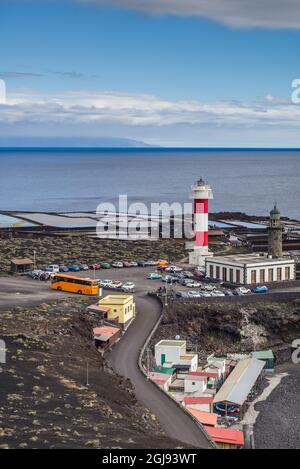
[0,149,300,219]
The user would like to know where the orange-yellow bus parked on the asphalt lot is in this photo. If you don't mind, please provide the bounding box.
[51,273,99,295]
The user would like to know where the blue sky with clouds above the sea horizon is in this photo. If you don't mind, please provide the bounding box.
[0,0,300,146]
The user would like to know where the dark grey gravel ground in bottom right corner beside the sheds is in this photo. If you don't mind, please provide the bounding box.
[254,363,300,449]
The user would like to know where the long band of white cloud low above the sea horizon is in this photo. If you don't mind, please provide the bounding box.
[0,87,300,128]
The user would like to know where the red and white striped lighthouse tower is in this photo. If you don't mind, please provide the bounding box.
[190,178,213,265]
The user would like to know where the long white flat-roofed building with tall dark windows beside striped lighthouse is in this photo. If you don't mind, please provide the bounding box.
[205,254,296,285]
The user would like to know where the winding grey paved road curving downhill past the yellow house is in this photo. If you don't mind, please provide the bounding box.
[107,293,211,448]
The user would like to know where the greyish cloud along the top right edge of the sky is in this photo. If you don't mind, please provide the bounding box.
[76,0,300,29]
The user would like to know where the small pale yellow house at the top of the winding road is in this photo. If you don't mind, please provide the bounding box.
[98,295,135,325]
